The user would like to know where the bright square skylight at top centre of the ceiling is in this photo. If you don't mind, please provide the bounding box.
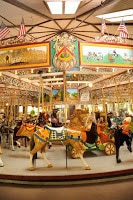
[45,0,81,14]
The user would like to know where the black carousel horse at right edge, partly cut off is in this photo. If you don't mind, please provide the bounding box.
[114,117,133,163]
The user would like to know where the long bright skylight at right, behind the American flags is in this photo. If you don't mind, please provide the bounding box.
[96,9,133,22]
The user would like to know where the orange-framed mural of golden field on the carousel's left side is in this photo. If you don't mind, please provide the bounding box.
[0,43,50,70]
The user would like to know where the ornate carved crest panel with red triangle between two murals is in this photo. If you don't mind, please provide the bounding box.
[51,33,79,71]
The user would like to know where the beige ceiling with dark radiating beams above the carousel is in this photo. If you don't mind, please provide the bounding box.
[0,0,133,43]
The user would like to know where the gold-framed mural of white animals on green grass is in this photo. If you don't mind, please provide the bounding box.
[80,43,133,67]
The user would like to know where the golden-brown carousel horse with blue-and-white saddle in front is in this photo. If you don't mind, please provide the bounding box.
[16,109,90,170]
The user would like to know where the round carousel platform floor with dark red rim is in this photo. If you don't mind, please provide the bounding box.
[0,144,133,186]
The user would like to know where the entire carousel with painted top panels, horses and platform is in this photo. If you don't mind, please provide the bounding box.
[0,29,133,184]
